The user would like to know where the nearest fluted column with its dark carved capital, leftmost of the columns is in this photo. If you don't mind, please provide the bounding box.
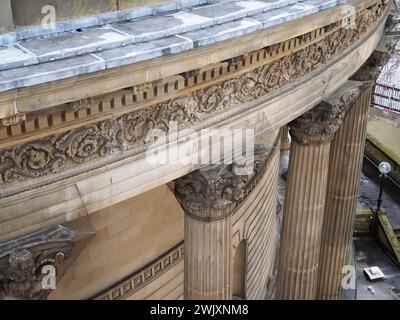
[174,145,269,300]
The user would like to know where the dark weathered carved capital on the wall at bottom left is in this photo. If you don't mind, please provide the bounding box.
[0,226,75,300]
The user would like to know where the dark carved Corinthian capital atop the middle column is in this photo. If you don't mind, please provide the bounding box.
[290,81,366,145]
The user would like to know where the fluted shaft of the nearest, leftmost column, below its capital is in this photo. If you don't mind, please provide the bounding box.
[184,215,233,300]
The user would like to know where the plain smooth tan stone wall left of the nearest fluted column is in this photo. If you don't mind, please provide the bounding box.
[49,185,184,299]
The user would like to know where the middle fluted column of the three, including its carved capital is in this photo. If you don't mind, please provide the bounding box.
[276,83,360,299]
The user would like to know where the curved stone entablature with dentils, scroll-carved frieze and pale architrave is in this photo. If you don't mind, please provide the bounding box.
[0,1,388,240]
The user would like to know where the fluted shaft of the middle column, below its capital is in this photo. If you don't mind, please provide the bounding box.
[276,140,330,299]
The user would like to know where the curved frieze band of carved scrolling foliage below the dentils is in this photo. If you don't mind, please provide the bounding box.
[0,3,390,188]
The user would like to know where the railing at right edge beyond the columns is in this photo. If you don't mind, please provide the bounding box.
[372,81,400,114]
